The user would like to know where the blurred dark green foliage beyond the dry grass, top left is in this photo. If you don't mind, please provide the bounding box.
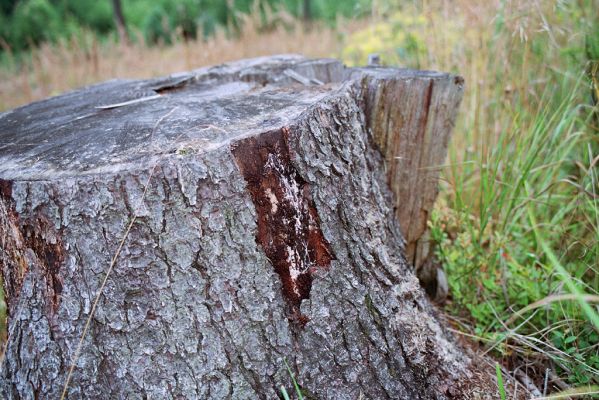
[0,0,371,51]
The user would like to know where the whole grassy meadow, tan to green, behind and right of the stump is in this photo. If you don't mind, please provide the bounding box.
[0,0,599,391]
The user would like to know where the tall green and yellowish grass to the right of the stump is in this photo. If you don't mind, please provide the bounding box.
[344,0,599,389]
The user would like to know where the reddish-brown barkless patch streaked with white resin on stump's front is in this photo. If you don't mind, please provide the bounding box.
[231,128,335,326]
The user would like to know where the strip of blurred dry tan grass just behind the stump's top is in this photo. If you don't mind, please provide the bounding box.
[0,13,354,111]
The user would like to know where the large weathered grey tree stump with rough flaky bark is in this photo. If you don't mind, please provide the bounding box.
[0,56,494,399]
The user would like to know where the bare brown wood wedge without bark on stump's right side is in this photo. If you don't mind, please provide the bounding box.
[356,65,463,297]
